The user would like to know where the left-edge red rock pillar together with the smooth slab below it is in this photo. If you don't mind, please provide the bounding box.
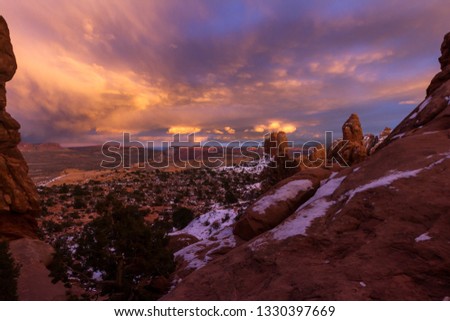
[0,16,66,300]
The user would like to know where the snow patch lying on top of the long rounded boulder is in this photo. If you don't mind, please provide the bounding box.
[252,179,312,214]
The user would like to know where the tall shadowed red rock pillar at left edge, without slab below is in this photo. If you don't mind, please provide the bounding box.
[0,16,39,239]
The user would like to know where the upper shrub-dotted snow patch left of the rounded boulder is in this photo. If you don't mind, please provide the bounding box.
[169,209,237,240]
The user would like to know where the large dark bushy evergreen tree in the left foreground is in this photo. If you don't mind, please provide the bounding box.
[75,207,175,300]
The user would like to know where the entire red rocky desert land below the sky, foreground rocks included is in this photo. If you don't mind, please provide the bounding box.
[0,3,450,301]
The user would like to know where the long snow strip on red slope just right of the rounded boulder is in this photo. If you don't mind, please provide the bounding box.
[271,175,346,240]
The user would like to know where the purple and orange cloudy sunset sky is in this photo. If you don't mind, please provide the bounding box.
[0,0,450,146]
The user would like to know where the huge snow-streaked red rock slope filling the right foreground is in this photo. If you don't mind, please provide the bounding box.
[164,31,450,300]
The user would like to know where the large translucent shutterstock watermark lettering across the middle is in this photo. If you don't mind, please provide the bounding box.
[100,131,348,169]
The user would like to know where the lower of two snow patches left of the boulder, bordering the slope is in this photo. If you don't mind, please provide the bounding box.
[174,226,236,270]
